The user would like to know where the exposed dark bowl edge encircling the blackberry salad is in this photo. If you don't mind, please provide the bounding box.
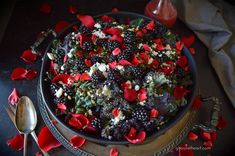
[39,12,197,145]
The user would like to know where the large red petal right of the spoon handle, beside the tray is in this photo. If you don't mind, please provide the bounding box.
[38,126,61,151]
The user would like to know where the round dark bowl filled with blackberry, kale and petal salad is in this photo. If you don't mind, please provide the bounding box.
[39,12,197,144]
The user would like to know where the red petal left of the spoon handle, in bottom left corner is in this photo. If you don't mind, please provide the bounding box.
[7,134,24,151]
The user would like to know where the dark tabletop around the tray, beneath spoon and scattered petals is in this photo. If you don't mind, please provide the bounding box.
[0,0,235,156]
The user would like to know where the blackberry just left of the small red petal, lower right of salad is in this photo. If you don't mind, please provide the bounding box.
[131,107,149,122]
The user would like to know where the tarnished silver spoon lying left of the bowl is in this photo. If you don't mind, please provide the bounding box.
[15,96,37,156]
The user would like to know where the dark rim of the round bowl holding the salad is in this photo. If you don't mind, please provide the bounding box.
[39,12,198,145]
